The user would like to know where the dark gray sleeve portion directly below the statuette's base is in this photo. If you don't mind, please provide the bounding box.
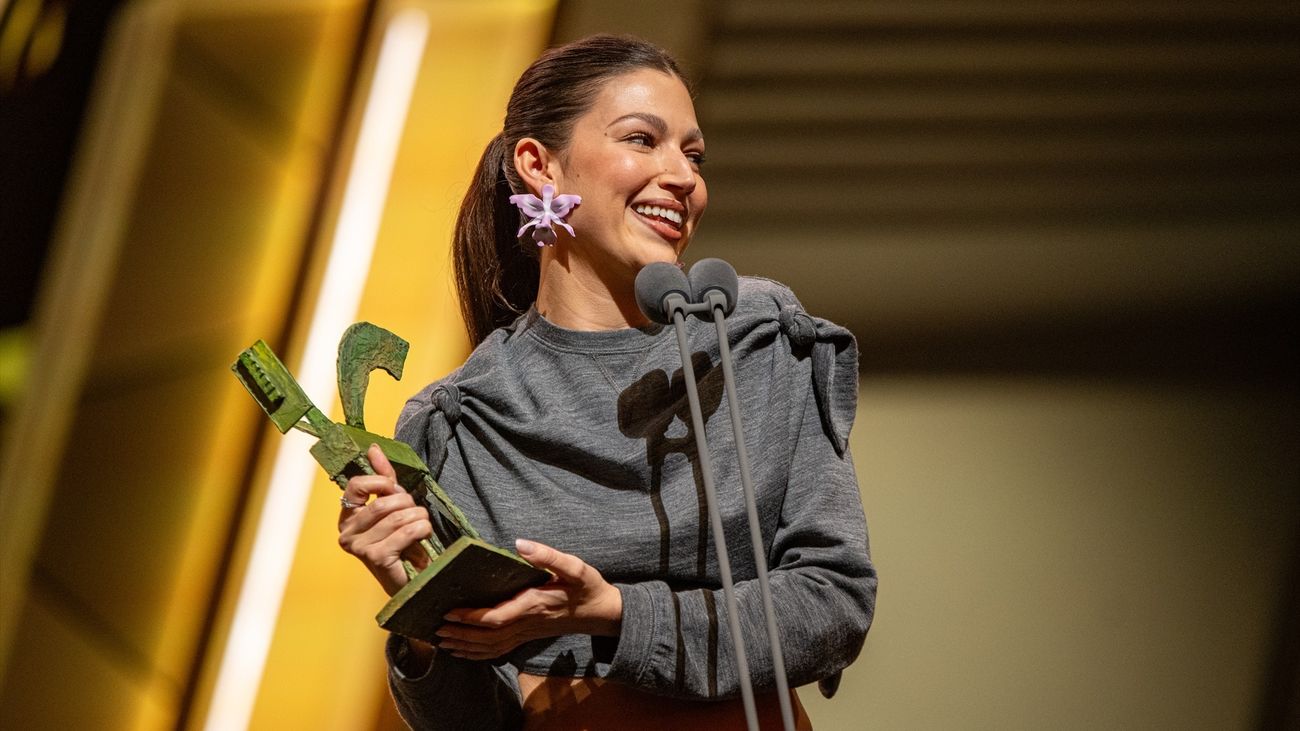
[385,635,524,731]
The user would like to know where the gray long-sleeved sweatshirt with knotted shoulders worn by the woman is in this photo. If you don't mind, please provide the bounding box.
[389,277,876,728]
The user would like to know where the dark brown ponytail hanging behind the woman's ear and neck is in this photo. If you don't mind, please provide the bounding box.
[452,134,538,346]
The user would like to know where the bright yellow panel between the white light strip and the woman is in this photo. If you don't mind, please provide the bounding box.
[245,0,555,730]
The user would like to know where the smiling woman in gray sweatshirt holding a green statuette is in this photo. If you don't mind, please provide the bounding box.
[339,36,876,728]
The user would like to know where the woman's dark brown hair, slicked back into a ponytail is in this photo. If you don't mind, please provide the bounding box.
[452,35,685,346]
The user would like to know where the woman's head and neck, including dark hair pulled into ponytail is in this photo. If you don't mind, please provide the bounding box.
[455,36,709,343]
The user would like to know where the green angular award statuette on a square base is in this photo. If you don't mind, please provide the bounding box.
[230,323,551,641]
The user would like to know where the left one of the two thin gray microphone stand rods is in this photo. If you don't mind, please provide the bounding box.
[666,295,759,731]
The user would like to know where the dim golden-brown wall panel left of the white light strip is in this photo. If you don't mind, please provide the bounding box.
[0,0,364,728]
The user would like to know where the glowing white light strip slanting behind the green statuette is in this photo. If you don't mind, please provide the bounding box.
[205,8,429,731]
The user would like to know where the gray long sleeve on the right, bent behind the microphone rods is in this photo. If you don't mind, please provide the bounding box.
[608,361,876,698]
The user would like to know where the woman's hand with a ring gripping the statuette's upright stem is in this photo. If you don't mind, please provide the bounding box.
[338,445,433,596]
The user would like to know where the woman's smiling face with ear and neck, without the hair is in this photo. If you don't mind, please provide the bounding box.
[525,69,709,329]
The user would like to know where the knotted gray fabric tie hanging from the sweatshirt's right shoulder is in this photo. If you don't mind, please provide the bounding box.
[777,302,858,457]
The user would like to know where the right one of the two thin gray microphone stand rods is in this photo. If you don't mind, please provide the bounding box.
[709,293,794,731]
